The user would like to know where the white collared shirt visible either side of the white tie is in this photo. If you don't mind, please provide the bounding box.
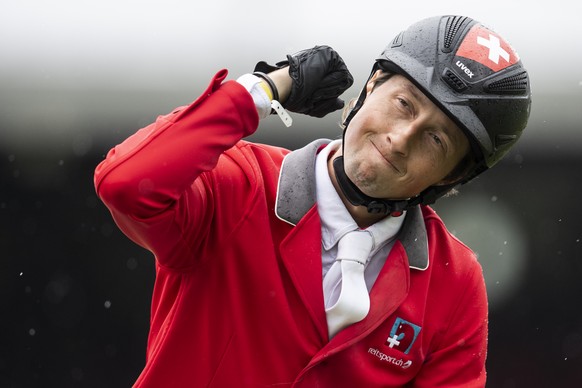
[315,140,405,292]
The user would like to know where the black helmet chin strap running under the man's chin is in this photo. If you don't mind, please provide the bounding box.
[333,156,420,217]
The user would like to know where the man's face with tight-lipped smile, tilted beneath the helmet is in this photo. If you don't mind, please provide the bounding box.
[344,73,469,199]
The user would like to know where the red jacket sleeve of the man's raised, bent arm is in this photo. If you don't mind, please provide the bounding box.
[94,70,259,265]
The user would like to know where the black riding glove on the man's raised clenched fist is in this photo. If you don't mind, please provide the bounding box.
[255,46,354,117]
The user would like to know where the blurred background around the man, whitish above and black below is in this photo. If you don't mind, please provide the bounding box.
[0,0,582,388]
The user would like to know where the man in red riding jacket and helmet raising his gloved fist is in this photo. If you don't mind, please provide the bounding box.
[95,16,530,387]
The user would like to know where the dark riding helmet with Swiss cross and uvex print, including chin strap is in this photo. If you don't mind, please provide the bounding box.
[334,15,531,214]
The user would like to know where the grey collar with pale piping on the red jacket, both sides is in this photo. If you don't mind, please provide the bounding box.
[275,139,429,270]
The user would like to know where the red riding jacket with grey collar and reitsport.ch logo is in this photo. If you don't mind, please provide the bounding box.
[95,70,487,388]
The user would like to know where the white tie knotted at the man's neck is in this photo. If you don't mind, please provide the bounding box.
[323,230,374,338]
